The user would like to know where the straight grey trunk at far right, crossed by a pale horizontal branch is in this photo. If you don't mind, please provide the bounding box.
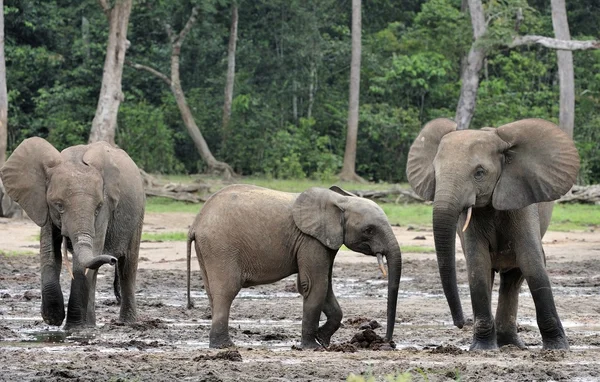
[552,0,575,138]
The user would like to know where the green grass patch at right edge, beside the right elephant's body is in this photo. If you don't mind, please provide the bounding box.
[548,204,600,231]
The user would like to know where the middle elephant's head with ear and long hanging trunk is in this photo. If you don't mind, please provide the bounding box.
[292,186,402,341]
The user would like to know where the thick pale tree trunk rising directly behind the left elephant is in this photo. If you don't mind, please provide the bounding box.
[88,0,133,145]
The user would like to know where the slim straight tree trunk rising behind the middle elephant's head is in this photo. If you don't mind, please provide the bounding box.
[340,0,364,181]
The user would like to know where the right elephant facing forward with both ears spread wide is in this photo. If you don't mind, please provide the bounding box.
[406,119,579,349]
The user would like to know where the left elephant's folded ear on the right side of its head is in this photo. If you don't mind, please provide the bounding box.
[83,142,121,207]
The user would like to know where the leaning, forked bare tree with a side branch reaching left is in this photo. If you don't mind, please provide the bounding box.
[129,7,235,178]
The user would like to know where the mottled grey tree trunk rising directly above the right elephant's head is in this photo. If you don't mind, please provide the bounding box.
[454,0,486,130]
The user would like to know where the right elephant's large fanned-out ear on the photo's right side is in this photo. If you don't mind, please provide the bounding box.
[492,119,579,210]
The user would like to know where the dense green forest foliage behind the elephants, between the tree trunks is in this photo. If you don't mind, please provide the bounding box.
[4,0,600,183]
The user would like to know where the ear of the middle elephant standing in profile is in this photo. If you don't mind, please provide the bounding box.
[292,187,344,249]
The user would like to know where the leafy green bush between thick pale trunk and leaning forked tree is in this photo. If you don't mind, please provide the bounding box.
[115,102,183,173]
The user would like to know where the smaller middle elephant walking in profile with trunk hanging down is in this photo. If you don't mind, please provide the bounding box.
[187,185,402,348]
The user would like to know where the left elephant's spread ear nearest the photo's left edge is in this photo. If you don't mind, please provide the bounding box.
[0,137,62,227]
